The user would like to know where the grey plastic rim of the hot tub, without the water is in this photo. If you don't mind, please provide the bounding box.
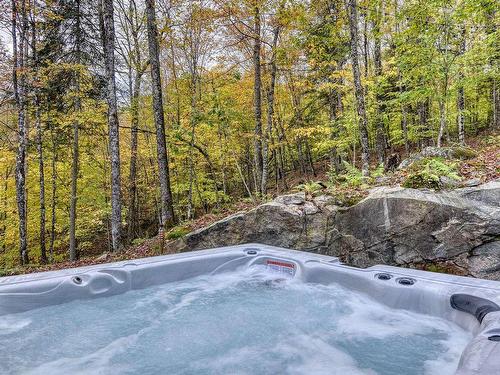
[0,244,500,375]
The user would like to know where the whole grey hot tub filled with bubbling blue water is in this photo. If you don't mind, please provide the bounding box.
[0,244,500,375]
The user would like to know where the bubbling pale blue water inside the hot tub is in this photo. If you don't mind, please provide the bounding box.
[0,269,470,375]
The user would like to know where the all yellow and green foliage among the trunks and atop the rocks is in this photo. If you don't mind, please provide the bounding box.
[0,0,500,274]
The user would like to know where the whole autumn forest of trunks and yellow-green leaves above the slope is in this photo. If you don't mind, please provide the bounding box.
[0,0,500,269]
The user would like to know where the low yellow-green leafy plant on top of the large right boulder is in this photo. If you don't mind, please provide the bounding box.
[403,158,460,190]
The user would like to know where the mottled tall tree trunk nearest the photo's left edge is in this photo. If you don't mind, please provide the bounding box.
[12,0,29,264]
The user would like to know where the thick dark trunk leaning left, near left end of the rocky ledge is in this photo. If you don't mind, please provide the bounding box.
[146,0,175,237]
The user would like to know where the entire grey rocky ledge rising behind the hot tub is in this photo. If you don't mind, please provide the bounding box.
[173,180,500,280]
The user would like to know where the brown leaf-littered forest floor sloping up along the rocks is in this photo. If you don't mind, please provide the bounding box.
[4,131,500,276]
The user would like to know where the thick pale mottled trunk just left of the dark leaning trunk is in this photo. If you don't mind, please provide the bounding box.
[101,0,122,251]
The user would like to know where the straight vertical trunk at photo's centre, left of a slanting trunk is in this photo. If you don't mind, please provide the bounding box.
[253,4,263,192]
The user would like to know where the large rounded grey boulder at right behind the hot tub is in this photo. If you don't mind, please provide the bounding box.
[325,182,500,278]
